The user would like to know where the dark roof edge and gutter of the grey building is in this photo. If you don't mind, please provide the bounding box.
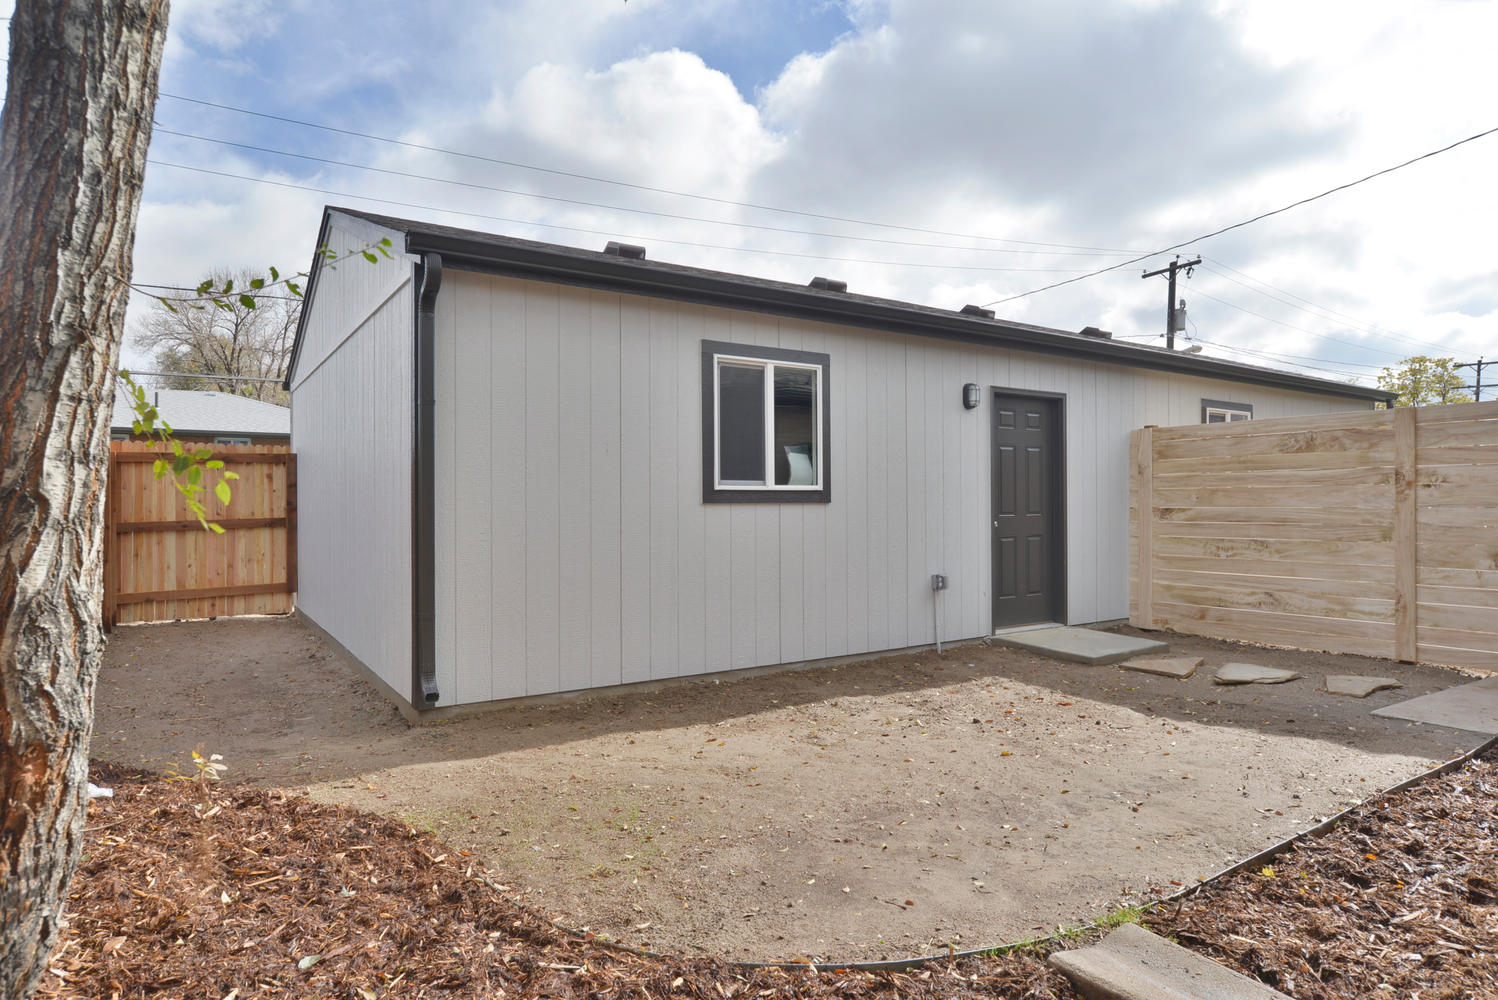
[285,205,1398,403]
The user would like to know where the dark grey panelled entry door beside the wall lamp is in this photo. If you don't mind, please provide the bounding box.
[992,392,1067,629]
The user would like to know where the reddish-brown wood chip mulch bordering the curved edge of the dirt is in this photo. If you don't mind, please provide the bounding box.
[39,757,1498,1000]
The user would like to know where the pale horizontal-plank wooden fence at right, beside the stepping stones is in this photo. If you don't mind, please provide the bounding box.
[1129,403,1498,669]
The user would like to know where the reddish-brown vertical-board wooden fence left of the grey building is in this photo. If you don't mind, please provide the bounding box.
[103,442,297,627]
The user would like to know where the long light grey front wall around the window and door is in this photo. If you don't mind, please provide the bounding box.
[428,268,1368,705]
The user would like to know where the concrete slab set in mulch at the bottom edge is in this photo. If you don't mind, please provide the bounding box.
[1049,924,1290,1000]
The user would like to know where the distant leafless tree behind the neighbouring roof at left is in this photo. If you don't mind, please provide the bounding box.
[132,269,301,404]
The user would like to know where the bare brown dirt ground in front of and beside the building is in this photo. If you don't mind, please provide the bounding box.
[93,618,1480,961]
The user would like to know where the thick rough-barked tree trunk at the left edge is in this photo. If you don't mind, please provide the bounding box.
[0,0,168,997]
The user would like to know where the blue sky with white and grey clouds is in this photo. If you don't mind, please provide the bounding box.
[0,0,1498,398]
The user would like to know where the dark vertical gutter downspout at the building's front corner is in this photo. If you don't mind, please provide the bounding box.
[410,253,442,710]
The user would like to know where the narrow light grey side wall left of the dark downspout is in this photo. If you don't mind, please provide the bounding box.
[292,231,415,692]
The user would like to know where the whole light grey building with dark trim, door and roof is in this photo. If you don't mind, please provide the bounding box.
[288,208,1389,710]
